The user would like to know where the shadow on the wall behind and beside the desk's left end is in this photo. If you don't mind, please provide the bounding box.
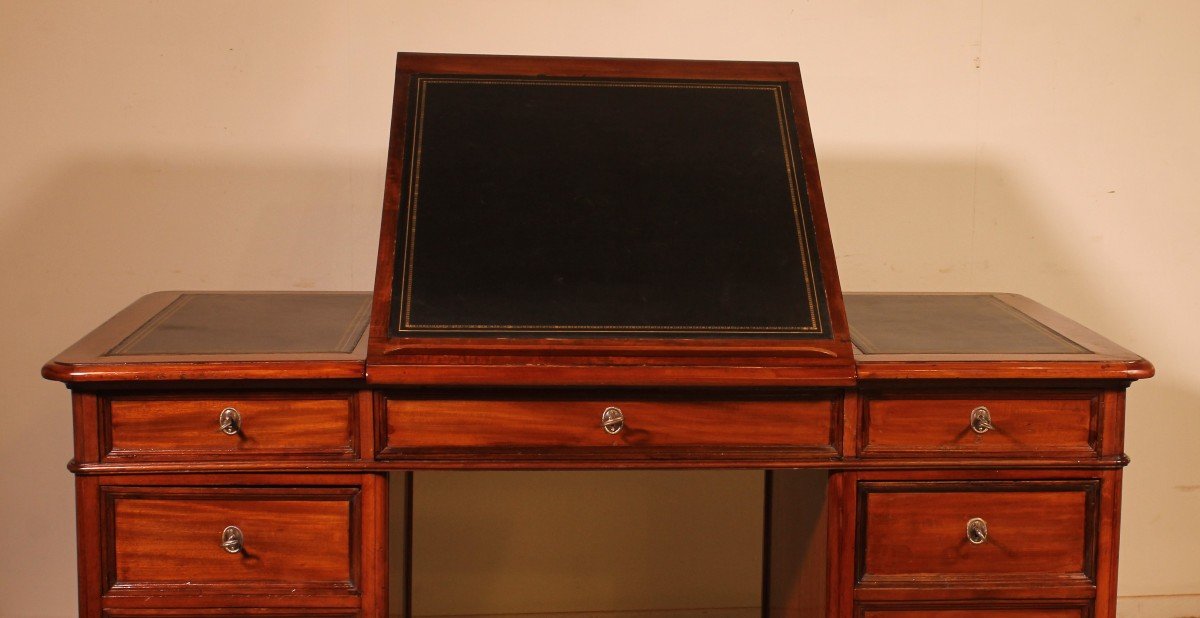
[0,156,383,616]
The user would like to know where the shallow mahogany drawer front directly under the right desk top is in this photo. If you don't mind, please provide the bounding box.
[860,391,1100,457]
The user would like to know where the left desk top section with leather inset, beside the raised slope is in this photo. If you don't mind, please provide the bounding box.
[42,292,371,383]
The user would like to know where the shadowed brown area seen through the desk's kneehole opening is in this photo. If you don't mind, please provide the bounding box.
[403,470,763,618]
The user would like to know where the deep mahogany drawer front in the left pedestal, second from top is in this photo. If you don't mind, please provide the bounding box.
[102,486,361,595]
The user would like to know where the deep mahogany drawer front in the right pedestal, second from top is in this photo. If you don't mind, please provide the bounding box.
[856,480,1099,588]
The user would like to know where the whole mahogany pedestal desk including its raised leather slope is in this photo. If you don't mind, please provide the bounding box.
[43,54,1153,618]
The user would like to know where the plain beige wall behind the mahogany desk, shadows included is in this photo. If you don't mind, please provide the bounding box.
[0,0,1200,617]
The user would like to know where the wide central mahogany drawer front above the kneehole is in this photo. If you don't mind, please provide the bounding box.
[382,395,840,456]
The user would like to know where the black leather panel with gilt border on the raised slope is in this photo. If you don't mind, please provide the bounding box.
[391,76,832,338]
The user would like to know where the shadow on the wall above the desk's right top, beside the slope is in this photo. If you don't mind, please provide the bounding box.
[821,156,1106,307]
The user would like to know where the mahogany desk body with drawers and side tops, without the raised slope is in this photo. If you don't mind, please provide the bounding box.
[44,292,1152,618]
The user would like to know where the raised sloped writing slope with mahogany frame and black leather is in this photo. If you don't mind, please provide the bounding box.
[368,54,853,384]
